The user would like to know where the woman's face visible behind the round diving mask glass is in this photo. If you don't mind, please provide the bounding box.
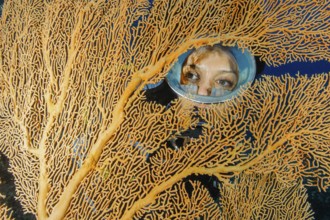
[181,48,238,96]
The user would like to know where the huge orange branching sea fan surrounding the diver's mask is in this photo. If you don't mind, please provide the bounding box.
[0,0,330,219]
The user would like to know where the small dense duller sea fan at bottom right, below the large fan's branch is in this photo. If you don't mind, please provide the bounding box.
[221,174,314,219]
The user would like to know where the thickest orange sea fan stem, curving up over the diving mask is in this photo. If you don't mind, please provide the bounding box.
[49,35,229,219]
